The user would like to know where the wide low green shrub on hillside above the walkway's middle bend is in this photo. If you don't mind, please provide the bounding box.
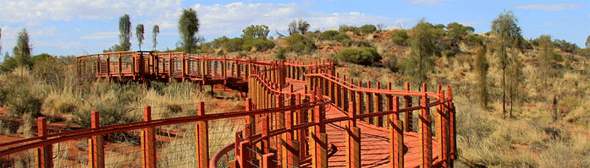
[337,47,381,65]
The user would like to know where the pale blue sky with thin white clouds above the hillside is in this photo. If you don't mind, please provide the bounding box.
[0,0,590,57]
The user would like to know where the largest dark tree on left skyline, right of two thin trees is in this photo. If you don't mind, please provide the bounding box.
[178,8,199,53]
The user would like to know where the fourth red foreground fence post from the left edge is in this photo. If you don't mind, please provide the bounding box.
[195,101,209,168]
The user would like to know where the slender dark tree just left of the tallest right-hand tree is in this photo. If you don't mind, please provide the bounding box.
[475,45,490,109]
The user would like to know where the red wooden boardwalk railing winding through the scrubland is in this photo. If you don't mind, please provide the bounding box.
[0,52,456,167]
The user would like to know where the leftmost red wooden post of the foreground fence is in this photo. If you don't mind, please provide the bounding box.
[37,117,53,168]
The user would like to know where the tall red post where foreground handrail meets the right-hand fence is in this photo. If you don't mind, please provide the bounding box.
[418,83,432,168]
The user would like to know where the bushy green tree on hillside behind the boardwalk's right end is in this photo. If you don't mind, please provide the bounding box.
[404,18,435,84]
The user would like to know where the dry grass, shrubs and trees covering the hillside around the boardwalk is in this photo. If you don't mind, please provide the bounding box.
[0,9,590,167]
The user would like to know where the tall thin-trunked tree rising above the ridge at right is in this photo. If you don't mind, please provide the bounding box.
[491,11,522,116]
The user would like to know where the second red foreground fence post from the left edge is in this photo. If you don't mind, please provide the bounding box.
[90,111,105,168]
